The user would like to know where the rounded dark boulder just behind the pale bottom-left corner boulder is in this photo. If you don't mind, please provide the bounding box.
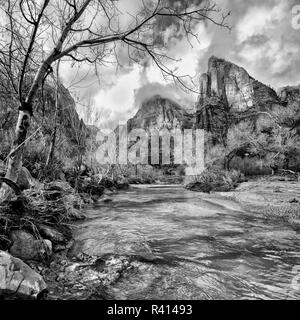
[9,230,52,261]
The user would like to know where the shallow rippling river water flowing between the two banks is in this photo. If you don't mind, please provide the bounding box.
[72,186,300,299]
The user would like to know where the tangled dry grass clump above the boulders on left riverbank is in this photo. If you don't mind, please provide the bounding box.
[0,188,80,250]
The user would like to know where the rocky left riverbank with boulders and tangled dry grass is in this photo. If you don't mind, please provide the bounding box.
[0,172,128,299]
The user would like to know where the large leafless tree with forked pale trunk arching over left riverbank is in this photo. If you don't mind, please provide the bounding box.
[0,0,228,198]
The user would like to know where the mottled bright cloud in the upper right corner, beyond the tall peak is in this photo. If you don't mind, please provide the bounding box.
[236,0,300,88]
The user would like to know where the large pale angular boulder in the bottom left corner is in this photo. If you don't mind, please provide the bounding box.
[0,251,47,299]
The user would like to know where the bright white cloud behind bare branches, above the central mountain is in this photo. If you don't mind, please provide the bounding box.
[77,18,210,126]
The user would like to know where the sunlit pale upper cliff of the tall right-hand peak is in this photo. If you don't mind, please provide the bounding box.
[197,56,280,111]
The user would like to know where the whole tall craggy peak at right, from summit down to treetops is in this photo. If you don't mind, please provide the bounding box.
[195,56,284,145]
